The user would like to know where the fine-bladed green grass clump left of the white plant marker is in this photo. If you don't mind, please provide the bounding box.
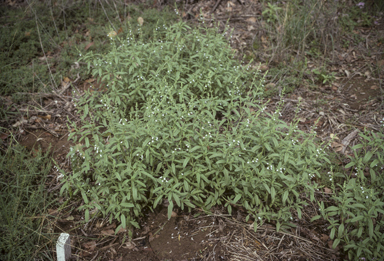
[0,141,55,260]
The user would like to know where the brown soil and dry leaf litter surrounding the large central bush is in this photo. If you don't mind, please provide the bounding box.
[0,0,384,261]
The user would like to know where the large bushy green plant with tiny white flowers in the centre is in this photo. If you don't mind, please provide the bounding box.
[61,20,328,236]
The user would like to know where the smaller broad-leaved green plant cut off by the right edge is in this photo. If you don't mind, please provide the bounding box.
[313,131,384,260]
